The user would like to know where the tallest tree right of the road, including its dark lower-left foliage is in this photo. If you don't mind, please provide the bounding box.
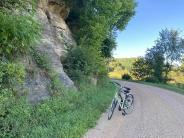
[145,29,184,82]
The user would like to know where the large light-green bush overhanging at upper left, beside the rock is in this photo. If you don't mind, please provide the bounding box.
[0,11,40,59]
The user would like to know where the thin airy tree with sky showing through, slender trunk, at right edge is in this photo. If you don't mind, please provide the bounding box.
[156,29,184,79]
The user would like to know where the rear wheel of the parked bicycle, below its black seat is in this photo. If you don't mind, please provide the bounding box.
[123,94,134,115]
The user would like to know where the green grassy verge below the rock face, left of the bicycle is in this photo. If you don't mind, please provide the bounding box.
[0,84,116,138]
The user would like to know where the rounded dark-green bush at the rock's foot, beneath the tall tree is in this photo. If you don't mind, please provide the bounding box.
[63,47,107,81]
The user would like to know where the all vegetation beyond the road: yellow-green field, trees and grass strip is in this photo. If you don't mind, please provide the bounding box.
[109,29,184,93]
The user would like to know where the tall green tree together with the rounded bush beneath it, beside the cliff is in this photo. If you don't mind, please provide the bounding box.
[64,0,136,80]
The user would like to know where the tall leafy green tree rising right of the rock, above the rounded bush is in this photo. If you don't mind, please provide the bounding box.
[66,0,136,81]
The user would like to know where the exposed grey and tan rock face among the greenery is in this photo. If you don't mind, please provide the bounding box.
[25,0,76,103]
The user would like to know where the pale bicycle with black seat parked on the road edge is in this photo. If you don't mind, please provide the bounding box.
[108,82,134,120]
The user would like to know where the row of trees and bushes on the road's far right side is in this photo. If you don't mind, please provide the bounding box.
[132,29,184,83]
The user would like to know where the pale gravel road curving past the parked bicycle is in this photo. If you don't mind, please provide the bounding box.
[84,82,184,138]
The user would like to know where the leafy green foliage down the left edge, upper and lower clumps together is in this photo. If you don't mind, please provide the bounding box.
[0,0,40,91]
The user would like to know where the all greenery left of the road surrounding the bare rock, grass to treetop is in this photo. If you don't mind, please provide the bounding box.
[0,0,136,138]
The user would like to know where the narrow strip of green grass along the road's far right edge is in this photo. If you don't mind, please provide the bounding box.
[133,81,184,95]
